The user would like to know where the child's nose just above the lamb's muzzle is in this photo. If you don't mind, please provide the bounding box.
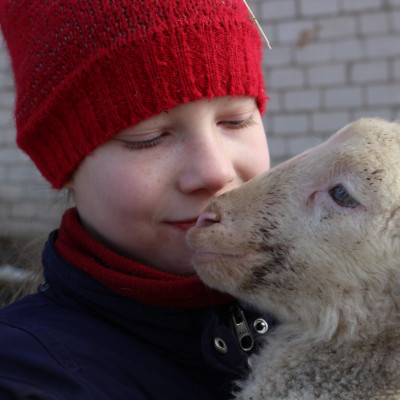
[180,139,236,193]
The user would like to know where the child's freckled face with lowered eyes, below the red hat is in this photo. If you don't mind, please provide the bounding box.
[66,96,269,275]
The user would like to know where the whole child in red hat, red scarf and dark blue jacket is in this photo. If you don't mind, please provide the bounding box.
[0,0,273,400]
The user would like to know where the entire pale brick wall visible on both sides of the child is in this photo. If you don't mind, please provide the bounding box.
[0,0,400,236]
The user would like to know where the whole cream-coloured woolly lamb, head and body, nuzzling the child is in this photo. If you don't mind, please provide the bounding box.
[188,118,400,400]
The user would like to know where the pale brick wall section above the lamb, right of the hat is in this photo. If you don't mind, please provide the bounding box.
[252,0,400,165]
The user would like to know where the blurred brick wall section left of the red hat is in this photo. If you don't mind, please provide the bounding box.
[0,36,66,237]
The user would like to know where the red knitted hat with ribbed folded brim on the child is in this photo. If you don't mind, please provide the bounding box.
[0,0,265,188]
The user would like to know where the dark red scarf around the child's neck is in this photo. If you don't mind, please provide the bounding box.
[55,208,232,307]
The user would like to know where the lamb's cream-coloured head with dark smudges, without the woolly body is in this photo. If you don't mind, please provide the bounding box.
[188,119,400,332]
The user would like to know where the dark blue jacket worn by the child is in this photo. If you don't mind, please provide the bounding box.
[0,233,273,400]
